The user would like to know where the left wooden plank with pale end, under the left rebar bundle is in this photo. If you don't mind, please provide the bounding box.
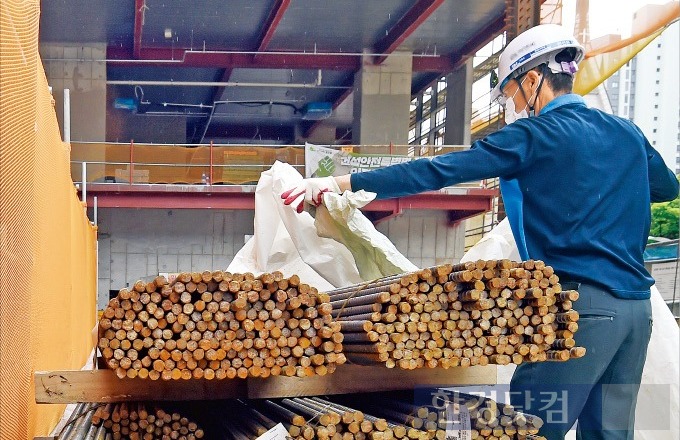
[35,370,247,403]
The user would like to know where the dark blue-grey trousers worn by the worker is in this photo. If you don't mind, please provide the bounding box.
[510,284,652,440]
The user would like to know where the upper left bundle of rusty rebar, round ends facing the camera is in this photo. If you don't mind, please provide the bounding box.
[98,271,345,380]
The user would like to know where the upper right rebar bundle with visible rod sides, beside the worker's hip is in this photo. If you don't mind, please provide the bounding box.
[327,260,585,369]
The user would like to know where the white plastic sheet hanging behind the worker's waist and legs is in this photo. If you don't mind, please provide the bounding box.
[461,219,680,440]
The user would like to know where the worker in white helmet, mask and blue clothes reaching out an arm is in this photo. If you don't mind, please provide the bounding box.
[282,25,678,440]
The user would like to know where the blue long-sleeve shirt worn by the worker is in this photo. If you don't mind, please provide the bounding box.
[351,94,678,299]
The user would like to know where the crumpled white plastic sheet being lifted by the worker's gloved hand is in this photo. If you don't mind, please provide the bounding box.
[227,162,417,290]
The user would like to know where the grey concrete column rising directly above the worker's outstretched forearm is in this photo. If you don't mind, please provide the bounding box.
[352,52,413,154]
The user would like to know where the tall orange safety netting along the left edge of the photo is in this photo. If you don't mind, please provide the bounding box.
[0,0,96,439]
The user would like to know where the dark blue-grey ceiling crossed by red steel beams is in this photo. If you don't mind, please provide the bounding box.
[40,0,506,142]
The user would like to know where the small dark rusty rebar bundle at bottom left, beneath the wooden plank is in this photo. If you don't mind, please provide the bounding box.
[91,402,204,440]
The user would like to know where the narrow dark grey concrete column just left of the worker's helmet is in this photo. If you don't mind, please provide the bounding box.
[444,58,472,145]
